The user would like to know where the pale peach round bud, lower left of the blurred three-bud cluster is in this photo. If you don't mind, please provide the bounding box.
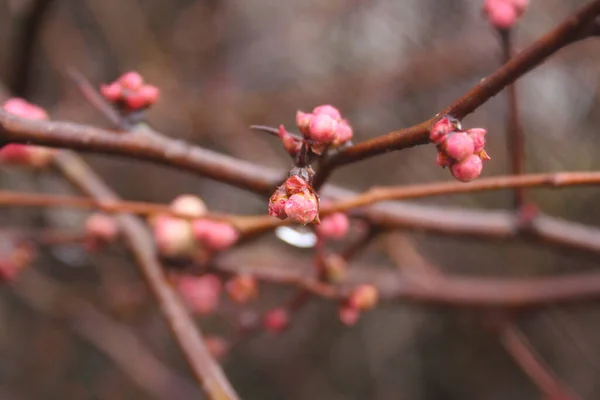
[153,215,195,257]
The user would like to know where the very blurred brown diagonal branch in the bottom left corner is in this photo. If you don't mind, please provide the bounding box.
[10,268,200,399]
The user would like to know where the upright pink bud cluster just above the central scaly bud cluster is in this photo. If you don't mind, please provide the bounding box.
[296,104,353,147]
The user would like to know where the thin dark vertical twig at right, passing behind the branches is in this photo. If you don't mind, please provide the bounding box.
[499,29,525,209]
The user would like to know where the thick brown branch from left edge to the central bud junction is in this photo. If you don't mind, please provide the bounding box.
[0,110,282,196]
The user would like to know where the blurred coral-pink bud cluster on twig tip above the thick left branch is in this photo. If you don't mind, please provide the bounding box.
[100,72,160,112]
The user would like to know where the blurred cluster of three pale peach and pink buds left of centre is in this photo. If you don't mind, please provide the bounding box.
[152,195,239,258]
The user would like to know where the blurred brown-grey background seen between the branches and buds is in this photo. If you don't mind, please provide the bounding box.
[0,0,600,400]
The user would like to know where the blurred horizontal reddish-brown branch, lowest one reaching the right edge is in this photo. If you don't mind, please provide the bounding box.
[218,265,600,309]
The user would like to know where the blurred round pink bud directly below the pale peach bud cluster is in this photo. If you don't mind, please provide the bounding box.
[177,274,222,314]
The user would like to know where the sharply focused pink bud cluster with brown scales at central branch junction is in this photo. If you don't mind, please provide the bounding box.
[269,175,319,225]
